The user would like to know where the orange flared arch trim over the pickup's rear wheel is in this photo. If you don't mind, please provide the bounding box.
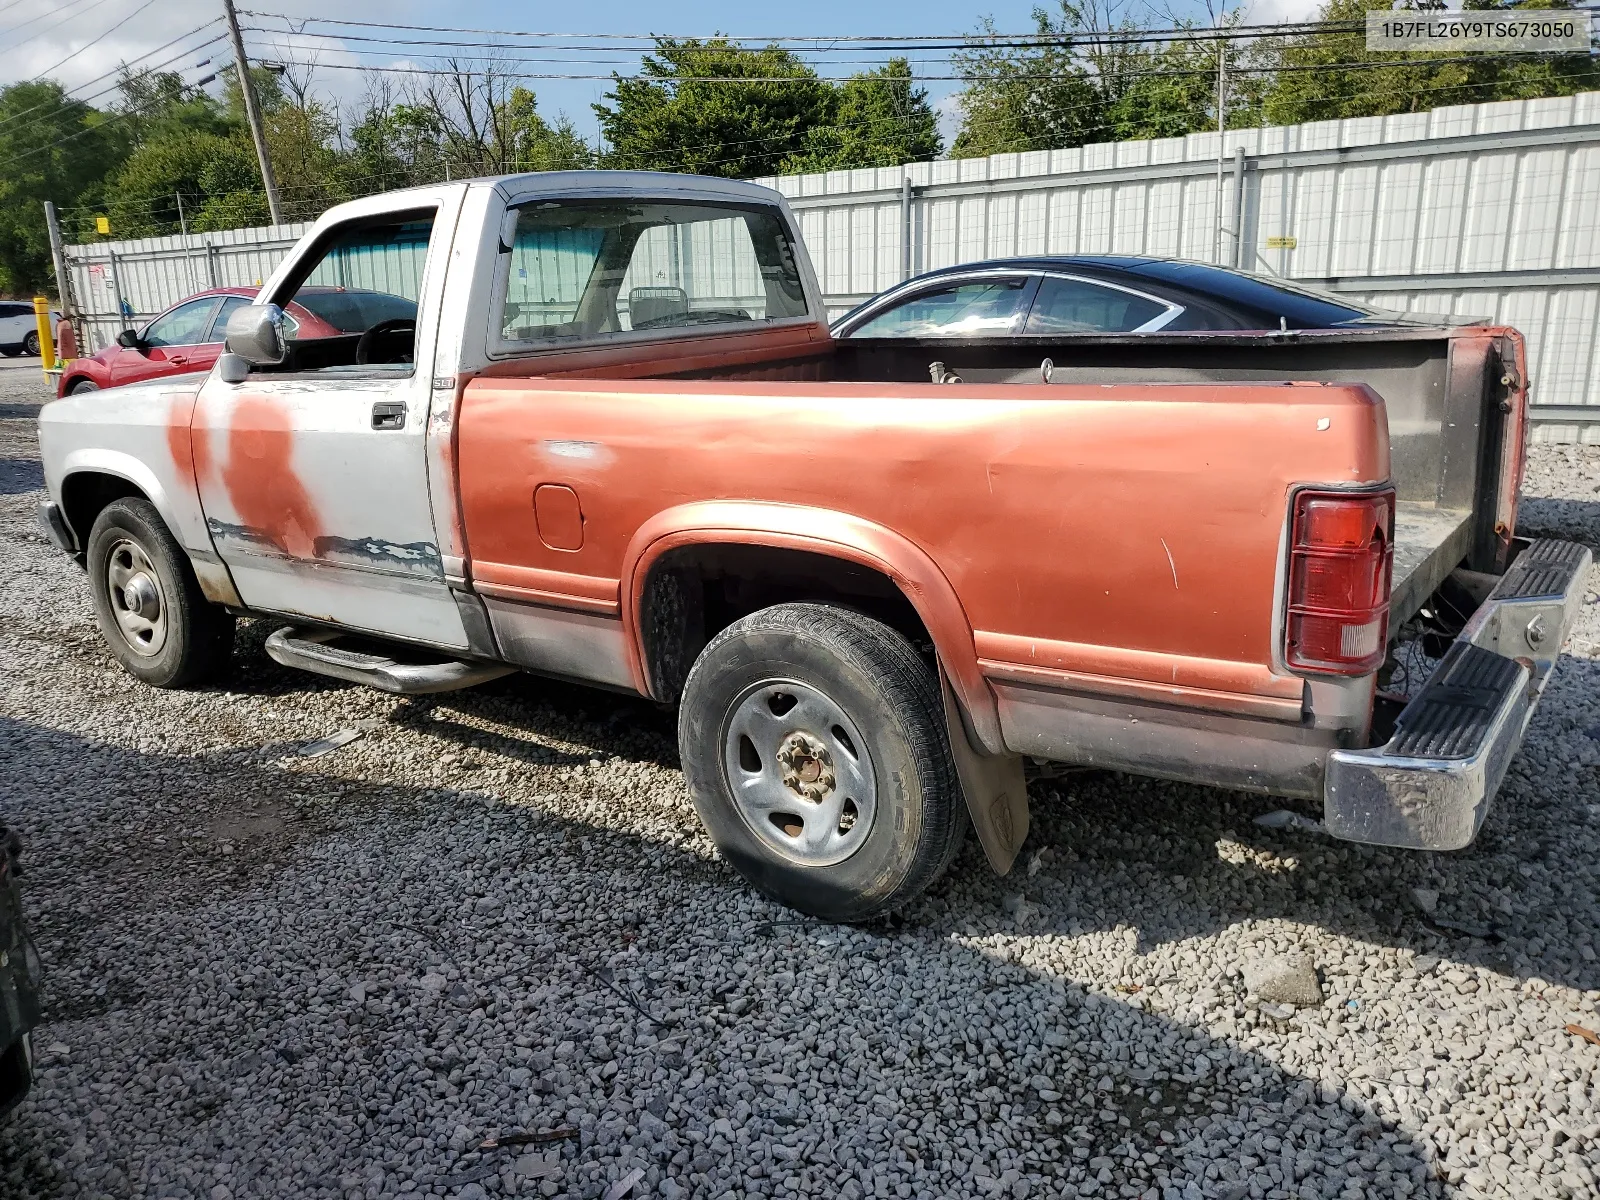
[619,501,1005,754]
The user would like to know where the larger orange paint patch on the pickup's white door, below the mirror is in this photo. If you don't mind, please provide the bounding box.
[222,397,322,558]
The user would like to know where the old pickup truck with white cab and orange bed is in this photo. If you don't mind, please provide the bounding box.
[40,173,1590,920]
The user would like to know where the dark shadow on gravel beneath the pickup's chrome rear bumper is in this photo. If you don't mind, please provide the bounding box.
[934,656,1600,990]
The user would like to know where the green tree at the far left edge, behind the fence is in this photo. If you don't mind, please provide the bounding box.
[0,80,123,296]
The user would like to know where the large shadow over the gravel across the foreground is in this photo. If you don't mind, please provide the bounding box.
[0,717,1445,1198]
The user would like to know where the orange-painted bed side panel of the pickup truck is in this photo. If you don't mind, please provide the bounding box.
[458,378,1389,713]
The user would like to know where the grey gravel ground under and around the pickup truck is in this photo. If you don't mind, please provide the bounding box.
[0,365,1600,1200]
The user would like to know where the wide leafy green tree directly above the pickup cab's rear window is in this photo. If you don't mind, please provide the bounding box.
[594,37,835,179]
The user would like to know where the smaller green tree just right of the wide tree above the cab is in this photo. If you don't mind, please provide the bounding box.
[781,58,944,174]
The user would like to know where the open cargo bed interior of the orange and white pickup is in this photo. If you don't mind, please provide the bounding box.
[488,326,1520,630]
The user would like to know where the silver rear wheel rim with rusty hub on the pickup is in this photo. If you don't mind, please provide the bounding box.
[722,680,878,867]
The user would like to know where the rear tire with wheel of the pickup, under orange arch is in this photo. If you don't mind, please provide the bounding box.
[678,603,966,922]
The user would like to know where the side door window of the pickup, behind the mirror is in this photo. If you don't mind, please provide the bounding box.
[268,213,434,374]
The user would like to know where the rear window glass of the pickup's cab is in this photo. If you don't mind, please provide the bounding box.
[499,200,808,350]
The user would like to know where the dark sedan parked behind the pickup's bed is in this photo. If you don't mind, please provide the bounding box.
[834,254,1469,338]
